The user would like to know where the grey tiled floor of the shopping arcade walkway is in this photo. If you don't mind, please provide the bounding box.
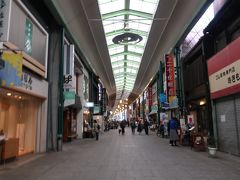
[0,129,240,180]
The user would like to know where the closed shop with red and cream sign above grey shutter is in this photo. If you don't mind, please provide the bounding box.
[208,37,240,155]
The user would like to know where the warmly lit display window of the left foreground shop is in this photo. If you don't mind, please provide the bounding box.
[0,88,41,155]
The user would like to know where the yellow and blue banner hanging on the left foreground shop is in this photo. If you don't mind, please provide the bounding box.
[0,52,23,87]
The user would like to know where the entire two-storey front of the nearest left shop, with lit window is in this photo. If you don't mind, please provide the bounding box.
[0,0,48,159]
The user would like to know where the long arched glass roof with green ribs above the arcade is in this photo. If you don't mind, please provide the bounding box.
[98,0,159,107]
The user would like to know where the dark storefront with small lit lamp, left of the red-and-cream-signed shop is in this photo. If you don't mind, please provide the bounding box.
[182,40,212,136]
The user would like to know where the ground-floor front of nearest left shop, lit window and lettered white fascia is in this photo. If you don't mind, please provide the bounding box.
[0,68,48,159]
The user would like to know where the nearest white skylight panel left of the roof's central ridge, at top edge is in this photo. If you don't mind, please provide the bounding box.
[98,0,124,14]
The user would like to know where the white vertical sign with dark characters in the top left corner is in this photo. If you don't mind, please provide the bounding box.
[0,0,12,42]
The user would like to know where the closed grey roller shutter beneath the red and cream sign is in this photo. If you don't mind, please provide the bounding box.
[216,96,239,154]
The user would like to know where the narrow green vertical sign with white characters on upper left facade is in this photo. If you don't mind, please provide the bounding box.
[24,19,33,55]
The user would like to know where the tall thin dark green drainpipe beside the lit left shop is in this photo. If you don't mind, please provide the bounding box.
[57,28,64,151]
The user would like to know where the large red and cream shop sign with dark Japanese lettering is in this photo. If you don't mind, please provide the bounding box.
[208,38,240,99]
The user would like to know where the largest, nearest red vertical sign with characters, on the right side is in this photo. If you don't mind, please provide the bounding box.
[165,54,176,97]
